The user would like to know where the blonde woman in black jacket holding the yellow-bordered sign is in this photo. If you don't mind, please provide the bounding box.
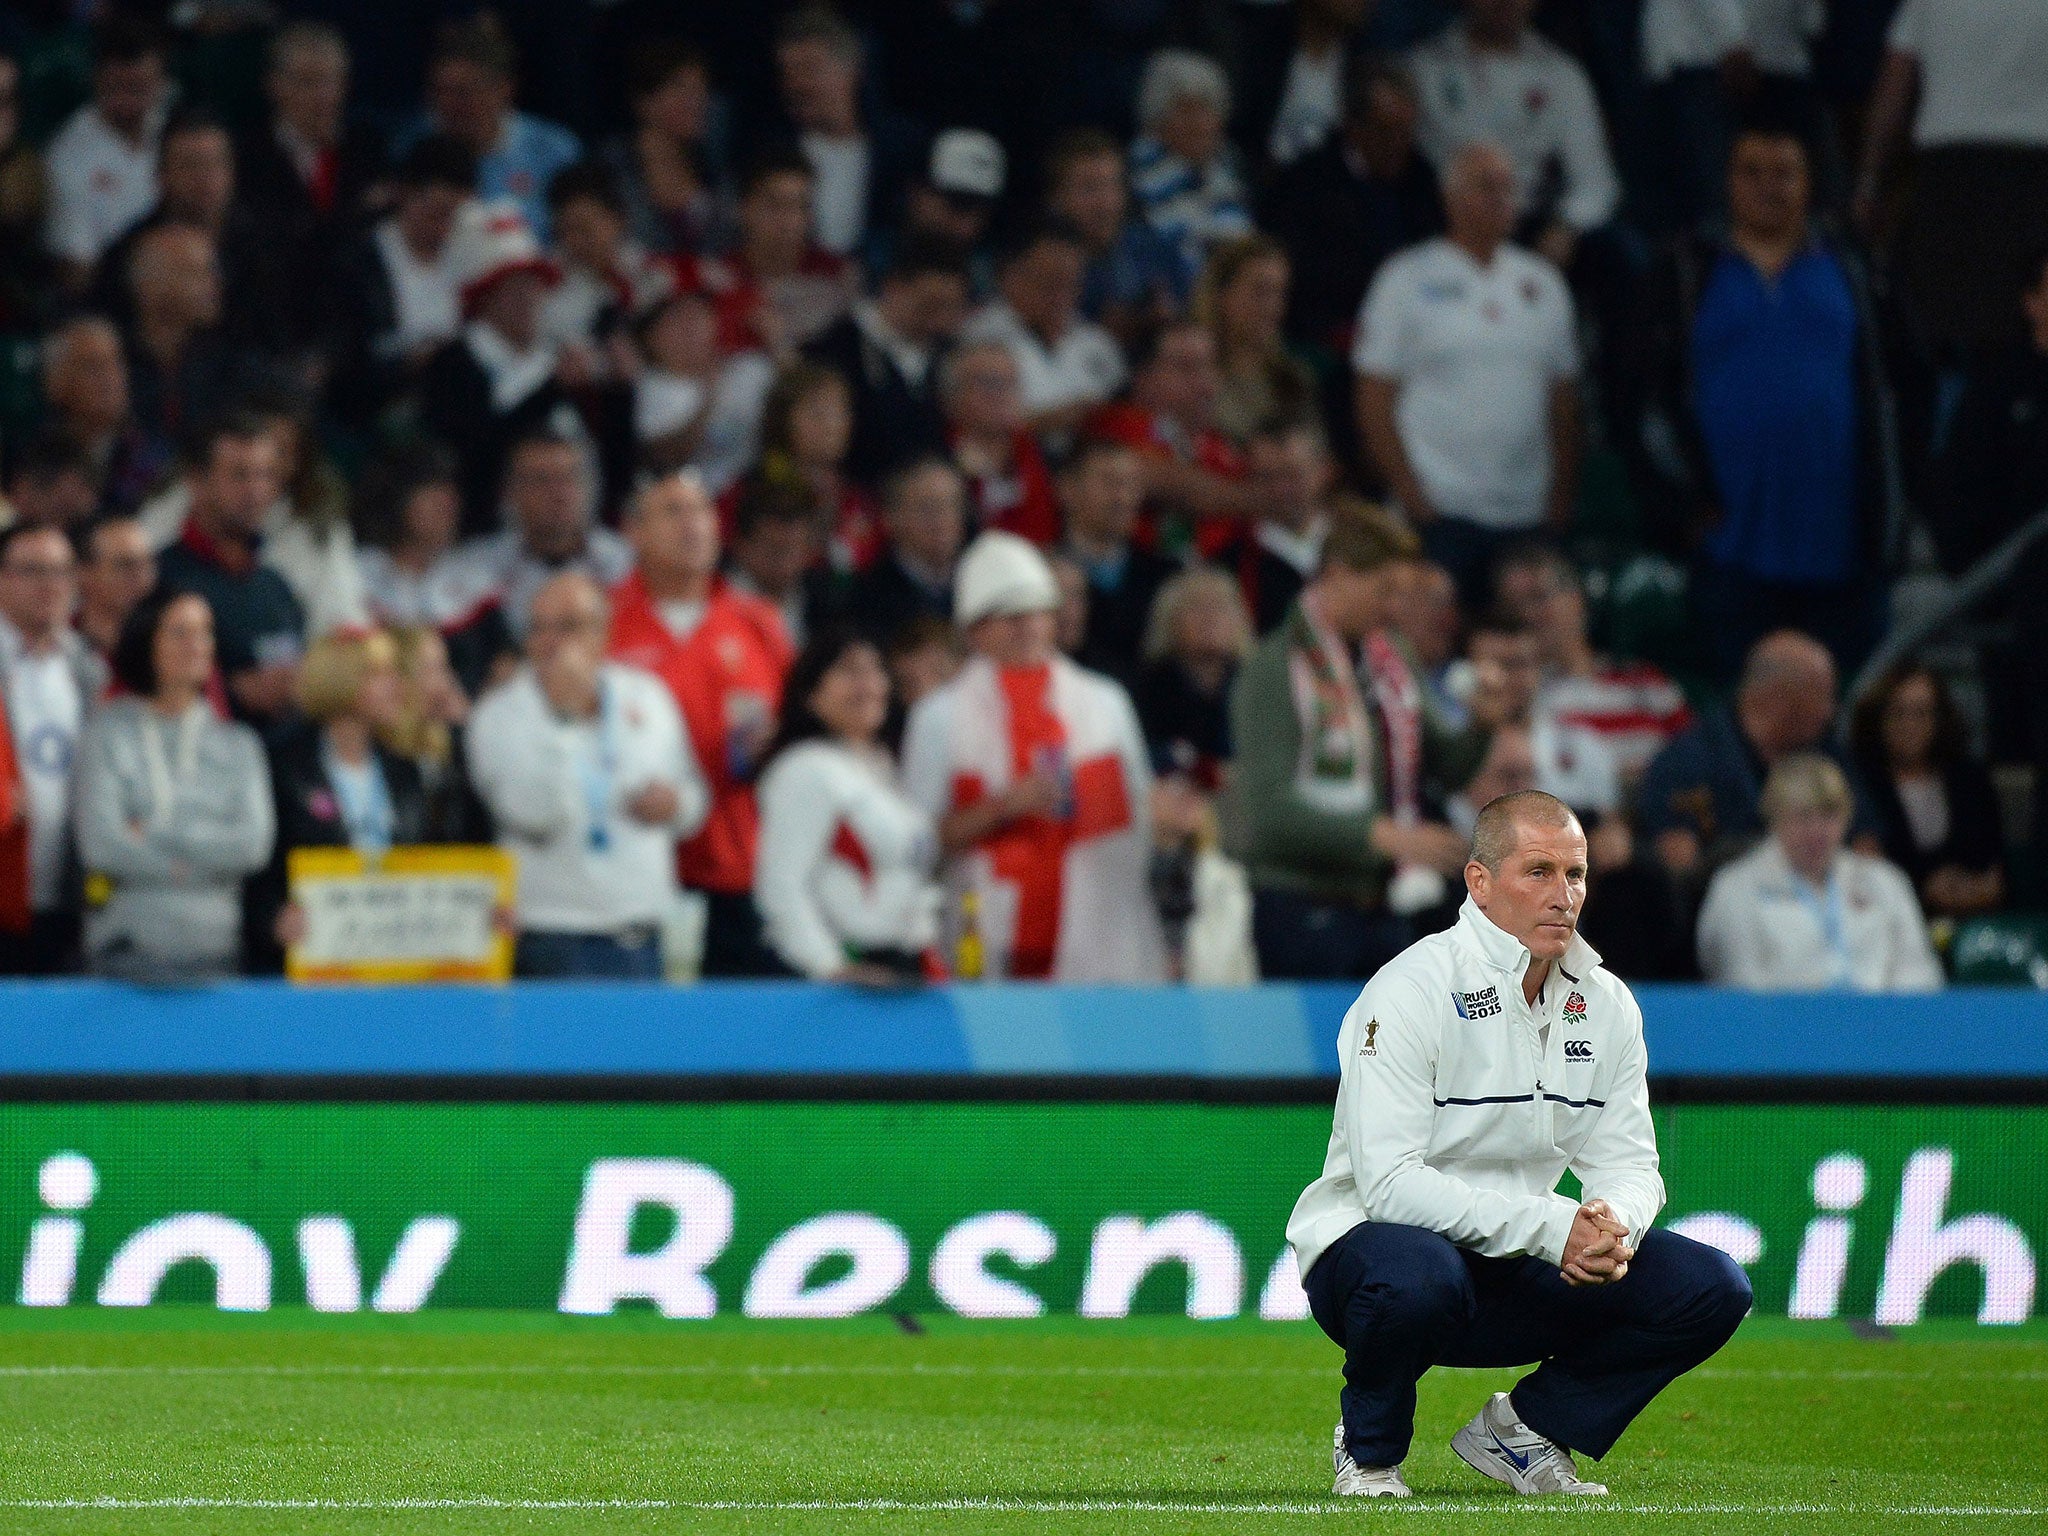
[246,629,426,975]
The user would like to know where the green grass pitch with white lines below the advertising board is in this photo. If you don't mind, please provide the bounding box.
[0,1307,2048,1536]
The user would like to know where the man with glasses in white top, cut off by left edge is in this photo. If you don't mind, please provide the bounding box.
[0,524,104,975]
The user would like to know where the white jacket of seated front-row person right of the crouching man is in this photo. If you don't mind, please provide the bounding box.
[1700,838,1942,991]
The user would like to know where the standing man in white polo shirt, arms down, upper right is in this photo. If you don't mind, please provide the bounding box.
[1352,143,1579,602]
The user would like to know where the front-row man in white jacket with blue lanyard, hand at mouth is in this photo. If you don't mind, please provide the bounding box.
[465,571,711,981]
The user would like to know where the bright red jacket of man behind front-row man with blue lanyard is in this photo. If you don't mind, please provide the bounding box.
[612,571,795,895]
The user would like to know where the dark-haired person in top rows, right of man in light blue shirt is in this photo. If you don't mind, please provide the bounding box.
[604,39,733,256]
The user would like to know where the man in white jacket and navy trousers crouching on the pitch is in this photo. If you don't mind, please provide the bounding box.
[1288,791,1749,1499]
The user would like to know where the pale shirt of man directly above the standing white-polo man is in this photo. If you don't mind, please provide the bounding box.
[1409,23,1622,229]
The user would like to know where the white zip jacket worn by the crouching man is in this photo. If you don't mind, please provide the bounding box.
[1286,901,1665,1278]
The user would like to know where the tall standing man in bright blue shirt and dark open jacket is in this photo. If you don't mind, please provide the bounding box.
[1655,129,1888,674]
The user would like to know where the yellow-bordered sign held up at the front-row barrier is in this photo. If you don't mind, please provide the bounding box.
[285,846,518,983]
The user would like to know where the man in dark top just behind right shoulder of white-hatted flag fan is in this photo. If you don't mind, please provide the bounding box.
[1059,436,1180,688]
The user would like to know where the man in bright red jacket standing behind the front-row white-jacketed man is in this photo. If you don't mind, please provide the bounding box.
[612,475,791,977]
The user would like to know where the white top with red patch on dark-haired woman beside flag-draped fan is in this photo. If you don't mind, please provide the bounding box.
[754,739,940,981]
